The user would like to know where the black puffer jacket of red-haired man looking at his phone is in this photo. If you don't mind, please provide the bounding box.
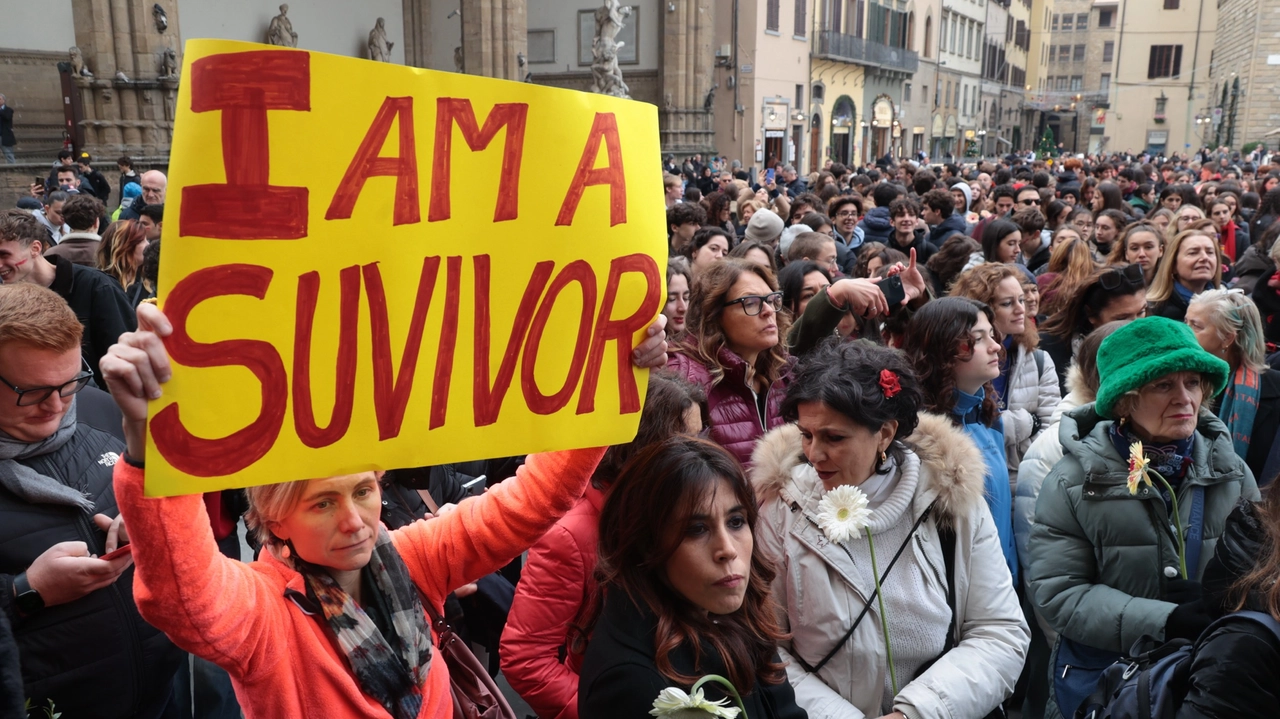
[0,388,182,719]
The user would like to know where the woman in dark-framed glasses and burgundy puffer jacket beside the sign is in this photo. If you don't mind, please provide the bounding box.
[667,260,791,464]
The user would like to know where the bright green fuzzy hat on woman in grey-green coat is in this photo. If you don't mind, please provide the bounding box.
[1093,317,1231,420]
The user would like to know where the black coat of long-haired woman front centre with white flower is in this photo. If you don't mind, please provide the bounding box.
[577,591,808,719]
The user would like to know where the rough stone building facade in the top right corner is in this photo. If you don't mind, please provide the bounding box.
[1197,0,1280,150]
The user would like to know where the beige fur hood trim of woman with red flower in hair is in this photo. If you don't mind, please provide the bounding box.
[750,412,986,517]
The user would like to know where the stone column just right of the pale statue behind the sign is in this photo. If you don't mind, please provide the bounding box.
[658,0,716,154]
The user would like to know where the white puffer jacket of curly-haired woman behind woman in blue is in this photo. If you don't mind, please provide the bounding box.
[1000,345,1061,486]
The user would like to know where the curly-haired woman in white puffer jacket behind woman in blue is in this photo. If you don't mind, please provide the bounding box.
[951,262,1062,491]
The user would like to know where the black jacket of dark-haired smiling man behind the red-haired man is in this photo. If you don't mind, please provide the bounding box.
[47,255,138,389]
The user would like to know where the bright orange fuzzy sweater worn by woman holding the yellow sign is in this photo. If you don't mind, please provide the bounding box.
[115,448,604,719]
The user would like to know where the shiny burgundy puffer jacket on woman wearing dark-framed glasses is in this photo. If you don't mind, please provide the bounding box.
[667,348,791,468]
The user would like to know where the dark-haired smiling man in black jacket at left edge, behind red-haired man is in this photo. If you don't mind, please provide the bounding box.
[0,210,138,388]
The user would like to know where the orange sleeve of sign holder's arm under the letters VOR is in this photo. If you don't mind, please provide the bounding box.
[392,446,605,609]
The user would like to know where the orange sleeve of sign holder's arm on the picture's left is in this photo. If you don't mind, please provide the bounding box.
[115,459,288,678]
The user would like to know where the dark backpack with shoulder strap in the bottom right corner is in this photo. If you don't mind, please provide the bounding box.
[1075,612,1280,719]
